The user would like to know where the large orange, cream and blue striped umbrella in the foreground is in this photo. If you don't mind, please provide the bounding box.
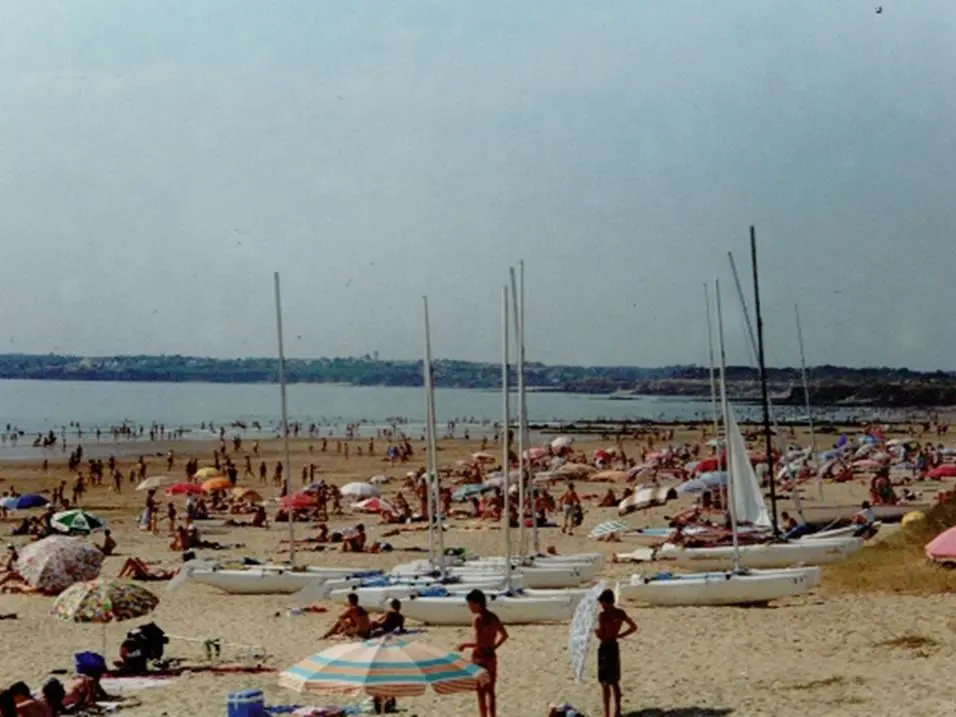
[279,635,488,697]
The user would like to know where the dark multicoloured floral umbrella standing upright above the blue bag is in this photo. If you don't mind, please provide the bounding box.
[53,578,159,623]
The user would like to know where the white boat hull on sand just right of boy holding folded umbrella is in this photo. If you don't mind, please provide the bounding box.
[619,567,820,607]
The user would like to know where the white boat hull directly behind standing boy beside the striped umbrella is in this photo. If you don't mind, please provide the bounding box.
[402,595,577,625]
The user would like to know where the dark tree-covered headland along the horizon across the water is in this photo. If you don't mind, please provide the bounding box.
[0,354,956,408]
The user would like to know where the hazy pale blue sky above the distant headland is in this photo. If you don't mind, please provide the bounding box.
[0,0,956,370]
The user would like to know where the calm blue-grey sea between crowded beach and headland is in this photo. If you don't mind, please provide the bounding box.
[0,380,888,460]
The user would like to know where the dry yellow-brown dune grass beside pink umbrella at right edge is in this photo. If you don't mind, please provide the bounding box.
[823,499,956,595]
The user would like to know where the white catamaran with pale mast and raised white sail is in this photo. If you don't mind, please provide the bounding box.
[618,284,820,605]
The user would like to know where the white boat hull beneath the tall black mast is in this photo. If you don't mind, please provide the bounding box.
[656,537,863,572]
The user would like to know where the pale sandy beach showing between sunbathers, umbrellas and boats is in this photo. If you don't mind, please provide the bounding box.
[0,432,956,717]
